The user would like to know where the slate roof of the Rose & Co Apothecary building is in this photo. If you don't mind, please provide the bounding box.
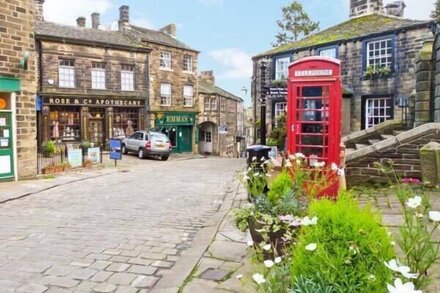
[35,22,144,49]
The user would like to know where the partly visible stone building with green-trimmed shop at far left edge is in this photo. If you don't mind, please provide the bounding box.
[0,0,42,180]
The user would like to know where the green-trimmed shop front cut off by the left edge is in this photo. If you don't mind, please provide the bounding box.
[0,77,20,181]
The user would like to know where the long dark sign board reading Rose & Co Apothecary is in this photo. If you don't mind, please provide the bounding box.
[43,97,145,107]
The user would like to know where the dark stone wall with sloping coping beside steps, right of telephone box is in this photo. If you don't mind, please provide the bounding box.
[346,123,440,186]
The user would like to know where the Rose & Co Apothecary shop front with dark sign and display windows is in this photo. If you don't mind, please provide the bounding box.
[40,97,146,148]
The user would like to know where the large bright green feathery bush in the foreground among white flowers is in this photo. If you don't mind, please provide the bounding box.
[291,194,394,292]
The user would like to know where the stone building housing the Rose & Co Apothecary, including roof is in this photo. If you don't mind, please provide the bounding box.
[35,13,151,147]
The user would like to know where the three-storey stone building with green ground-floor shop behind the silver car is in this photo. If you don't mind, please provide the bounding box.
[119,6,199,153]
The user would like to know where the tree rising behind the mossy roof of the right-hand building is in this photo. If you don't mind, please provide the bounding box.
[272,0,318,47]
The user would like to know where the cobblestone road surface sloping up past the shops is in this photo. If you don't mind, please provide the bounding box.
[0,158,244,293]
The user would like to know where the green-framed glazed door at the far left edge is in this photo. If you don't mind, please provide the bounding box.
[0,112,14,180]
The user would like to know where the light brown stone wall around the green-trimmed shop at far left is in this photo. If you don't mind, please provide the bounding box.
[0,0,38,178]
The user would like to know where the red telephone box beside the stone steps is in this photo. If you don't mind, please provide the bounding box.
[287,56,342,195]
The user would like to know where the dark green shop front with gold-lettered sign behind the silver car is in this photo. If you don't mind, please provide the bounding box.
[155,112,196,153]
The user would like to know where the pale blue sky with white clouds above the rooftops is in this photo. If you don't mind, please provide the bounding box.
[44,0,435,105]
